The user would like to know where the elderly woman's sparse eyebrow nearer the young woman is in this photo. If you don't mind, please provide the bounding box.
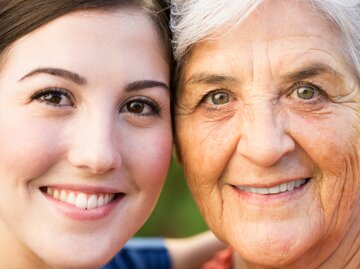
[181,72,238,87]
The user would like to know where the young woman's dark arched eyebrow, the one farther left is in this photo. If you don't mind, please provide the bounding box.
[19,67,87,86]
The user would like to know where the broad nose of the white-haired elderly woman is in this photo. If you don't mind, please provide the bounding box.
[237,103,295,167]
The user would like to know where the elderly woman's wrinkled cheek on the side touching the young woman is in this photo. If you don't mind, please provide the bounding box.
[175,115,239,233]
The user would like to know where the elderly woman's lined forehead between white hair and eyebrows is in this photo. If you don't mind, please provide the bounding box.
[185,1,344,68]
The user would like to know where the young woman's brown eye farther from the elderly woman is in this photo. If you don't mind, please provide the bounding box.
[31,88,74,106]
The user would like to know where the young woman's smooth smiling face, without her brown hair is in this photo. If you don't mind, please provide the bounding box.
[0,9,172,268]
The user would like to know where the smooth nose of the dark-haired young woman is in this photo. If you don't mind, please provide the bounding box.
[68,112,121,174]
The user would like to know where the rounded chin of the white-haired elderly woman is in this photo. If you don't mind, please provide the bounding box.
[228,221,320,268]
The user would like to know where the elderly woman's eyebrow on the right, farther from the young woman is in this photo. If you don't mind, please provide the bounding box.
[282,63,342,82]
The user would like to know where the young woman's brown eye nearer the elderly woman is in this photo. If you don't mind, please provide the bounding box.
[120,98,160,116]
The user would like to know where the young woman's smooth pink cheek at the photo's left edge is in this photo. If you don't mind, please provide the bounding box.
[0,111,63,180]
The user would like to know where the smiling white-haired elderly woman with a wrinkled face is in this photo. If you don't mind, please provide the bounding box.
[172,0,360,269]
